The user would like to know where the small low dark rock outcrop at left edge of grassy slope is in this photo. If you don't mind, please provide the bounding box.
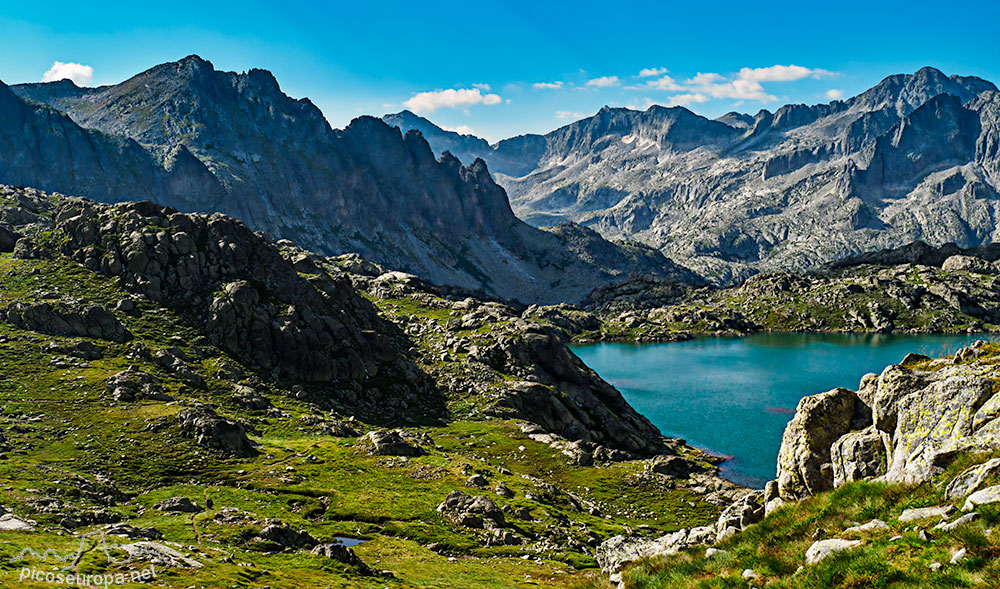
[0,302,131,342]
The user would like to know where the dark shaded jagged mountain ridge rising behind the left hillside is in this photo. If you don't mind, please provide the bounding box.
[0,56,698,303]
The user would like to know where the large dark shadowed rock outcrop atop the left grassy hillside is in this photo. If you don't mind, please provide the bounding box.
[57,201,393,382]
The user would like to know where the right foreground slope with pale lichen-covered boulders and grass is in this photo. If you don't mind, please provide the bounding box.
[595,342,1000,587]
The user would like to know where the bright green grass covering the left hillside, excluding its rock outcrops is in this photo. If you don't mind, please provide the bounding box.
[0,254,718,588]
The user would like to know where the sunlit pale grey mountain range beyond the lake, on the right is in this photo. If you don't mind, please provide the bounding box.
[386,68,1000,281]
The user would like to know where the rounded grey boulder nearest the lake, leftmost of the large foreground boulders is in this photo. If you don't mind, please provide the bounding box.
[777,388,862,501]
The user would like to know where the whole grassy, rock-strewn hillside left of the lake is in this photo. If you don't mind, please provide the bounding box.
[0,186,745,588]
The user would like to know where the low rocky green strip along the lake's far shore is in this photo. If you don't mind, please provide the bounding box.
[516,242,1000,343]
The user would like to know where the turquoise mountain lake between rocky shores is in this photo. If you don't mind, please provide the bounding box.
[573,333,994,488]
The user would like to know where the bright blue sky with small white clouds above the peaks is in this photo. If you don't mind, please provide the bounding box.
[0,0,1000,140]
